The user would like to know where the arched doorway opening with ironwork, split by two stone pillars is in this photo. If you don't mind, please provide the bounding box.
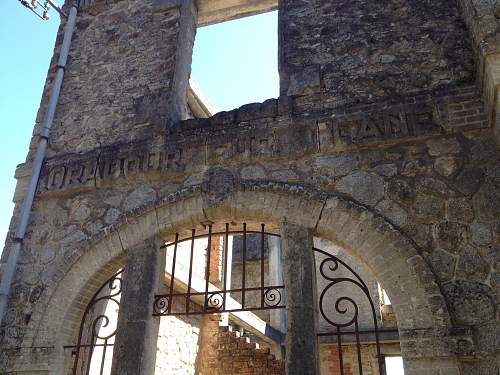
[66,223,403,375]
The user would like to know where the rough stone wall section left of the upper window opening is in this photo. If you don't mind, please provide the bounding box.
[27,1,196,160]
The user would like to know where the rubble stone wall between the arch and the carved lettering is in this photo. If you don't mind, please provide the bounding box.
[4,100,499,374]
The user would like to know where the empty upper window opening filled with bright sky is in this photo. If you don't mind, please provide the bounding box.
[191,11,279,112]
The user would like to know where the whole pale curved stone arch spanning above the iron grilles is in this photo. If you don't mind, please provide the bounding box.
[30,181,453,373]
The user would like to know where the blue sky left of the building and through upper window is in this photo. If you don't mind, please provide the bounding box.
[0,5,279,247]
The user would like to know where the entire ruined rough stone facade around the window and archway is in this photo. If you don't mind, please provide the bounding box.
[0,0,500,375]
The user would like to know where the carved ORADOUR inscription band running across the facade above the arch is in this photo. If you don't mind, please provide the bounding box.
[41,108,439,191]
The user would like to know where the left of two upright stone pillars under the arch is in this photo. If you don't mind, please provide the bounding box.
[111,239,165,375]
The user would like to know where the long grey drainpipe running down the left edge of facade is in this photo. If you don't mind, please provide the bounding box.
[0,4,77,325]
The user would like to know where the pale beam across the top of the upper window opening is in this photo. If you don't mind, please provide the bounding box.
[197,0,278,26]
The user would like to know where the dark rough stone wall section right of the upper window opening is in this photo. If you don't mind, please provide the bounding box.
[280,0,474,105]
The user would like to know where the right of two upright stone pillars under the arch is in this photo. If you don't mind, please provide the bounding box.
[281,221,320,375]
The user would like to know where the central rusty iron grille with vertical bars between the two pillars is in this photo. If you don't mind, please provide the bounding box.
[154,223,284,316]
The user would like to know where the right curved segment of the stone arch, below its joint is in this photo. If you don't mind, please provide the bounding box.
[316,197,450,330]
